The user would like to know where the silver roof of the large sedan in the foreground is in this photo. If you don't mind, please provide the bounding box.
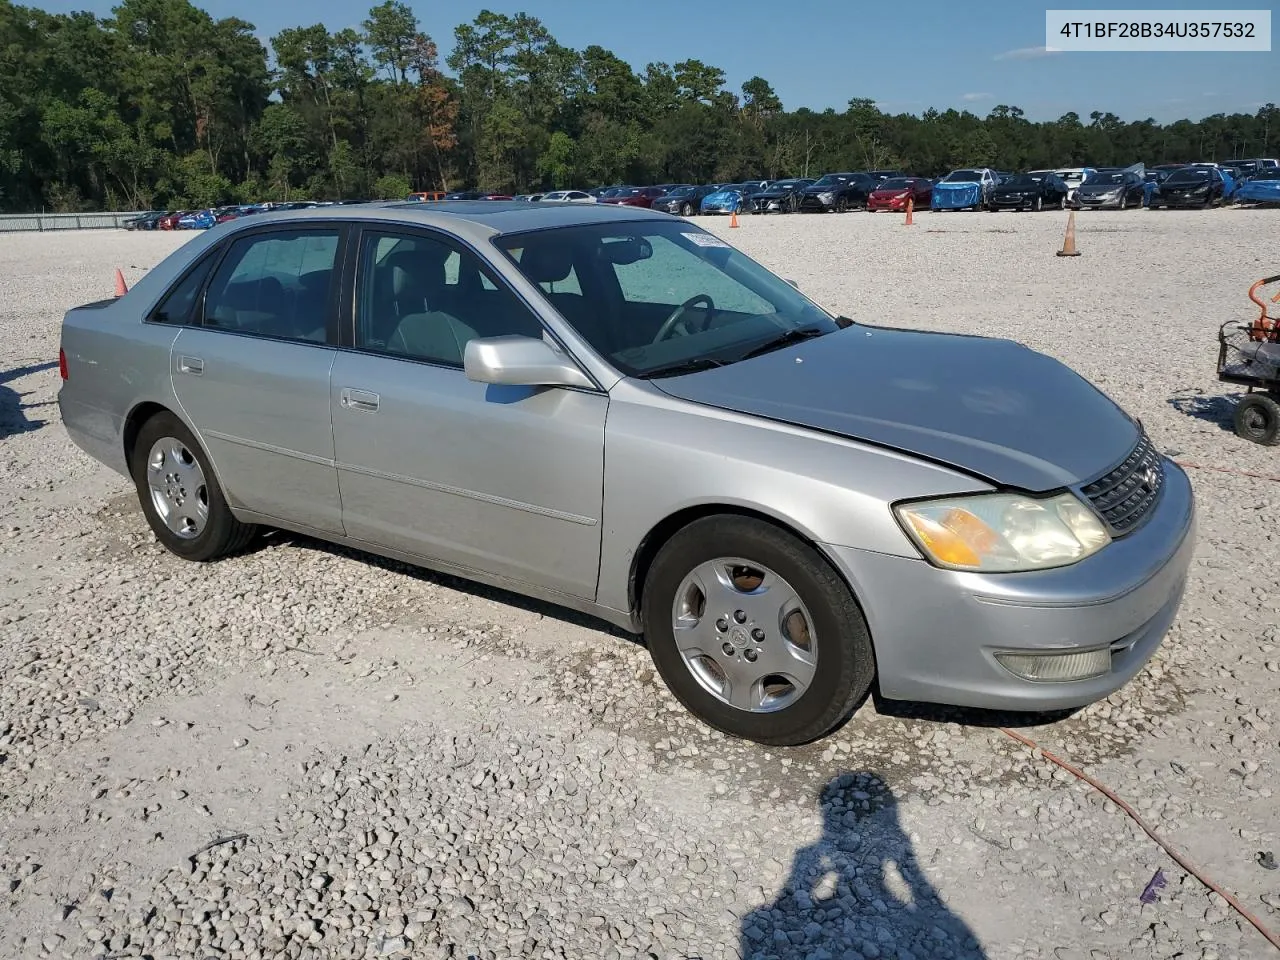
[216,200,671,239]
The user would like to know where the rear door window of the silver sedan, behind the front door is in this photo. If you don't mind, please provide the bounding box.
[204,229,338,343]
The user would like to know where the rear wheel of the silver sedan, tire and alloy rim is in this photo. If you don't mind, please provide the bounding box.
[129,412,256,563]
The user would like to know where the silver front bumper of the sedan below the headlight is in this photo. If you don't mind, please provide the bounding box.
[824,461,1196,712]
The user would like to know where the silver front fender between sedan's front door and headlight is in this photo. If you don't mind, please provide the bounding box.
[596,380,992,611]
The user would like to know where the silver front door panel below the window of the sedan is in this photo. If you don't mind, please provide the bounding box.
[321,351,609,600]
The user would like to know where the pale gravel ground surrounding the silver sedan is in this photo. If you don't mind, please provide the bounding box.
[0,210,1280,960]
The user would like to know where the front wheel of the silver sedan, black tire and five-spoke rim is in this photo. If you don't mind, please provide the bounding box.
[641,516,876,746]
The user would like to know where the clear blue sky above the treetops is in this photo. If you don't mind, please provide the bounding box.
[40,0,1280,122]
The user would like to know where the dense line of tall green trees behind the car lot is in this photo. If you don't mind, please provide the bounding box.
[0,0,1280,211]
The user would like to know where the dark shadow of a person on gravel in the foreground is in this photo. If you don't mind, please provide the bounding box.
[740,771,987,960]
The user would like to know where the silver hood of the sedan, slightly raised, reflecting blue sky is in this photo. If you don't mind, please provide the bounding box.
[653,325,1139,490]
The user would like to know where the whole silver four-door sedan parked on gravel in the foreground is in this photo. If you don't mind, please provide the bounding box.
[59,201,1194,744]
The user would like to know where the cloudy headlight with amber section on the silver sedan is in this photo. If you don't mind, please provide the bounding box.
[893,493,1111,573]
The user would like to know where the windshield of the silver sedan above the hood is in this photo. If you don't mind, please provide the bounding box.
[493,220,838,378]
